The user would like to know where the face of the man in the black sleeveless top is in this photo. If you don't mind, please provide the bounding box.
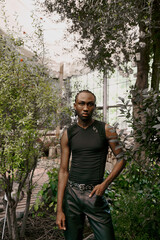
[74,92,95,121]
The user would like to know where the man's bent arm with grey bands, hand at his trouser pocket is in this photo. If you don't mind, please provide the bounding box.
[89,124,125,197]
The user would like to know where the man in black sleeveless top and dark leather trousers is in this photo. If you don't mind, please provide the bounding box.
[56,90,125,240]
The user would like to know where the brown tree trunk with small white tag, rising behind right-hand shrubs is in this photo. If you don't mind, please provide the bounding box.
[132,5,150,165]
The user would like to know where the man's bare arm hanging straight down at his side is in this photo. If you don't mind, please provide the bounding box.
[56,130,70,230]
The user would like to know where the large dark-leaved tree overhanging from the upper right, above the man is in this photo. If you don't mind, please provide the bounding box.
[44,0,160,90]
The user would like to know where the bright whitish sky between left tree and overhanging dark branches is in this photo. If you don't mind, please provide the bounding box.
[0,0,88,78]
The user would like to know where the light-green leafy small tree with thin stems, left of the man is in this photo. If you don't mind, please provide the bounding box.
[0,31,59,240]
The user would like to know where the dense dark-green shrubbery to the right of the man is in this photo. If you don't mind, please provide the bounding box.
[108,89,160,240]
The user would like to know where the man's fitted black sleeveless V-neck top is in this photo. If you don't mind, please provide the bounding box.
[67,120,108,185]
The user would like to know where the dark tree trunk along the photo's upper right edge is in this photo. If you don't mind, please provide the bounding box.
[151,0,160,91]
